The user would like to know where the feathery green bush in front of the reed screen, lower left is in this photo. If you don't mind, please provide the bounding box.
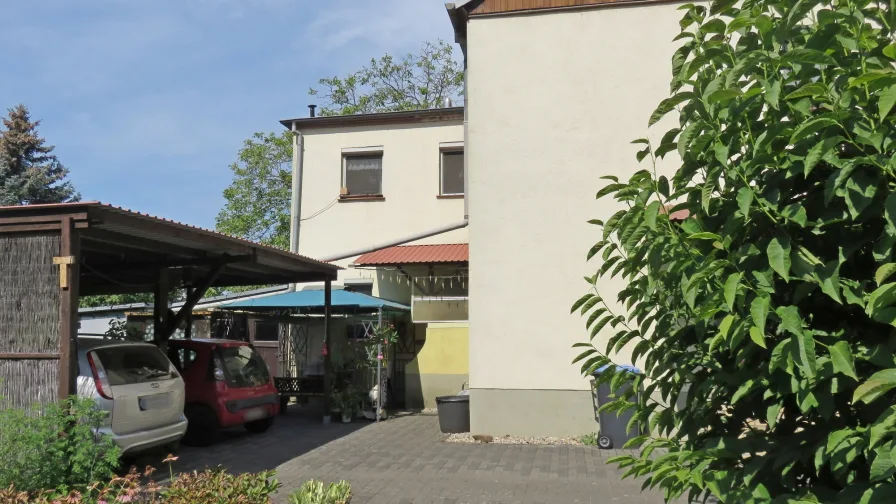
[0,398,119,492]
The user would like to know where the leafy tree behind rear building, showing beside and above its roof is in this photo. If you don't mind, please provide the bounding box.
[216,41,463,249]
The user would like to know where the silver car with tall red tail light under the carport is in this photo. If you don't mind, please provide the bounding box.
[78,337,187,455]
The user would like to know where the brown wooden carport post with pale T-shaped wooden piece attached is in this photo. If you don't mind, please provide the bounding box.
[53,216,81,399]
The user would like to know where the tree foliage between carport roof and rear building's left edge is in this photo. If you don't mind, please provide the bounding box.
[216,131,292,249]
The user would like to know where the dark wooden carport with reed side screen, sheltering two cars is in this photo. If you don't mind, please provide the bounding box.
[0,202,339,414]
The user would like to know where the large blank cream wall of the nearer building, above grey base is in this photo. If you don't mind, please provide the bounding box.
[466,4,681,390]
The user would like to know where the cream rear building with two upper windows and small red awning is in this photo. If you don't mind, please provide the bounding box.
[281,107,469,407]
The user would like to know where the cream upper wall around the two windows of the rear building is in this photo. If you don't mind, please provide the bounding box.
[299,120,468,302]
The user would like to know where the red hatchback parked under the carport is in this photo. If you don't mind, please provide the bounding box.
[168,339,280,446]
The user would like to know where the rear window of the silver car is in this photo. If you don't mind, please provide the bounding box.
[93,345,175,387]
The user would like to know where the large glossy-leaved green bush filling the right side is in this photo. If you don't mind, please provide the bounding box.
[573,0,896,504]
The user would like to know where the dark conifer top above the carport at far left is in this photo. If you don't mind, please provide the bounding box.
[0,105,81,206]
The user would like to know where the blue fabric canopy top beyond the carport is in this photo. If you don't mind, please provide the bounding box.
[219,289,411,311]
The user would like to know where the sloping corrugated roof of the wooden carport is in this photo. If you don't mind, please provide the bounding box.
[0,202,340,295]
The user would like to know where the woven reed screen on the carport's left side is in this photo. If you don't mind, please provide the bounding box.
[0,233,59,408]
